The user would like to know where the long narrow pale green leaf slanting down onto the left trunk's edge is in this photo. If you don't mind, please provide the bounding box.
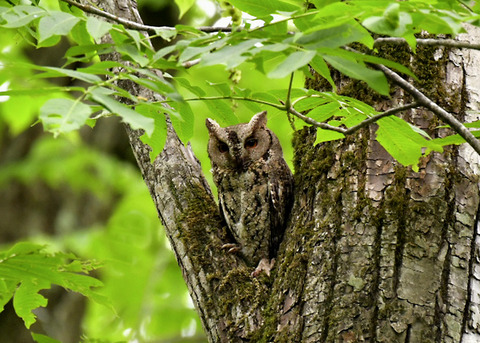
[90,87,155,136]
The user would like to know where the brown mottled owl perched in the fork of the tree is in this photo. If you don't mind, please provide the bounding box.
[206,111,293,275]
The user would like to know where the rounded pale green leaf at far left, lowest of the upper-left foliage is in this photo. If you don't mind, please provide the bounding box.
[40,99,92,136]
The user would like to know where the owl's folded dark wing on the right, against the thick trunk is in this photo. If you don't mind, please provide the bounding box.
[268,161,293,257]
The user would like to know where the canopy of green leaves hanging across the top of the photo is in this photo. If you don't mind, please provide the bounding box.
[0,0,478,166]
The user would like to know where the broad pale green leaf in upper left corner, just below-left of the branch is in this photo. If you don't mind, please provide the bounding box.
[38,11,80,46]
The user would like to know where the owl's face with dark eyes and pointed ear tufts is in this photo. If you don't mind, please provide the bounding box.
[206,111,273,171]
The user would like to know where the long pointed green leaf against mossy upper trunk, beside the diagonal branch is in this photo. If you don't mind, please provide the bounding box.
[323,55,390,95]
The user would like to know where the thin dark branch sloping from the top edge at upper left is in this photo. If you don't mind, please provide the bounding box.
[62,0,232,34]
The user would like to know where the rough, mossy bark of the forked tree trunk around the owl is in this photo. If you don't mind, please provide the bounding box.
[84,0,480,342]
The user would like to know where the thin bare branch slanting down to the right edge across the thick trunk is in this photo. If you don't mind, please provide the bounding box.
[375,64,480,155]
